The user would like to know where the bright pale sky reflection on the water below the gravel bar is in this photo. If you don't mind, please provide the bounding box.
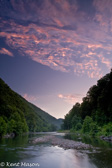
[23,146,97,168]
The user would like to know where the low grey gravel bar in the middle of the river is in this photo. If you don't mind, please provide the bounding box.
[32,135,92,149]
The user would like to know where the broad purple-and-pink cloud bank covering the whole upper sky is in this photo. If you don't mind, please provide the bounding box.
[0,0,112,78]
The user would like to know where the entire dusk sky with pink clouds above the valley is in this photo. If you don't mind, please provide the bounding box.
[0,0,112,118]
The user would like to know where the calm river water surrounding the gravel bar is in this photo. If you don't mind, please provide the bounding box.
[0,133,112,168]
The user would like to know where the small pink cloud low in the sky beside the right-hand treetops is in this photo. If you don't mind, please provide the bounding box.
[58,94,83,104]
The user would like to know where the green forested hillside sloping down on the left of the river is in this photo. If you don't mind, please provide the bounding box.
[0,79,62,136]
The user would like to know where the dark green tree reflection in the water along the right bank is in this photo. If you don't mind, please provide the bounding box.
[65,134,112,168]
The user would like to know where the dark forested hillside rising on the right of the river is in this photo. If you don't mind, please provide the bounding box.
[63,71,112,135]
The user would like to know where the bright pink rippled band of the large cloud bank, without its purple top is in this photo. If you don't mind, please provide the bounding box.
[0,20,110,78]
